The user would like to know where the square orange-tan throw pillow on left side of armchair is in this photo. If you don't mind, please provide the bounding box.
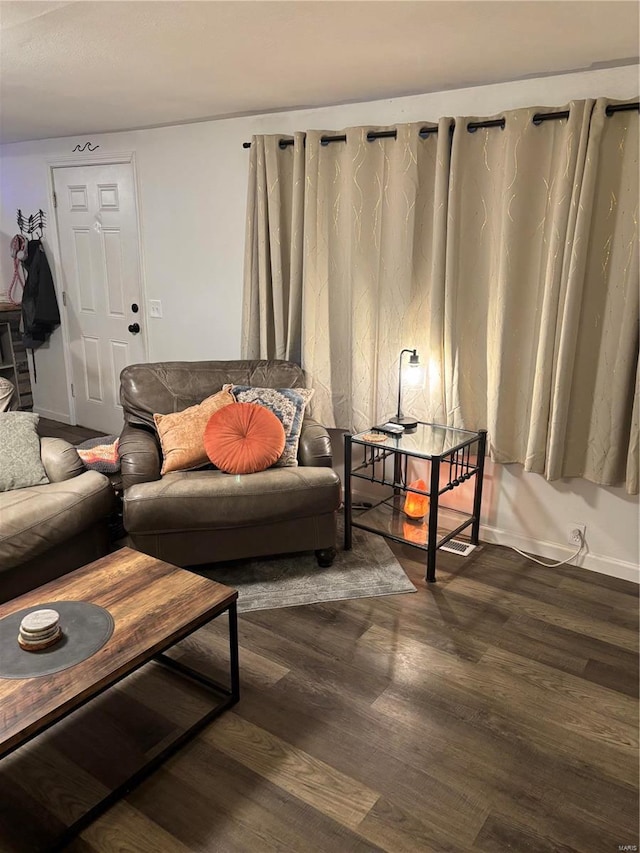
[153,388,235,474]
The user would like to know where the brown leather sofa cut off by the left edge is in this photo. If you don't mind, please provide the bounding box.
[0,438,115,602]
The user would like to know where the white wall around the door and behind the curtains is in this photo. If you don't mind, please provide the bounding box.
[0,66,639,578]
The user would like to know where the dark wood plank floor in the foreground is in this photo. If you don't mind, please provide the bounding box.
[0,422,639,853]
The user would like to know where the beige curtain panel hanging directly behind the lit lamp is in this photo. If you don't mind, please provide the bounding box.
[302,119,450,429]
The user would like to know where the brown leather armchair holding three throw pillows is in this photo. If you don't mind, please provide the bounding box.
[119,360,341,566]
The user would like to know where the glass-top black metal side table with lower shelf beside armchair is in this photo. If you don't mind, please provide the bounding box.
[344,422,487,582]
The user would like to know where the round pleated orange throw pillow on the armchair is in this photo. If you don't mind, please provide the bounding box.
[204,403,285,474]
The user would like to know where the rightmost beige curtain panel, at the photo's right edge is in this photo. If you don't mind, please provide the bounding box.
[545,99,640,486]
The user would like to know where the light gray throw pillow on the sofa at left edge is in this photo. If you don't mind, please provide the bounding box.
[0,412,49,492]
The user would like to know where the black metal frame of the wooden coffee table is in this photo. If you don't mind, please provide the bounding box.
[0,601,240,853]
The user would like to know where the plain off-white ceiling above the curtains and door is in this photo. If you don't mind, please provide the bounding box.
[0,0,640,142]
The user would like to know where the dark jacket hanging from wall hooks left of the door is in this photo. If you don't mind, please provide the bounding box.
[22,240,60,349]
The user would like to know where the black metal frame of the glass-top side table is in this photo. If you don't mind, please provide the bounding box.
[344,424,487,583]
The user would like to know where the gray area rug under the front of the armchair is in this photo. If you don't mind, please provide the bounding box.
[192,528,416,613]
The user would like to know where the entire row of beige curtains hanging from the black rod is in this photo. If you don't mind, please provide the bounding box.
[243,99,639,493]
